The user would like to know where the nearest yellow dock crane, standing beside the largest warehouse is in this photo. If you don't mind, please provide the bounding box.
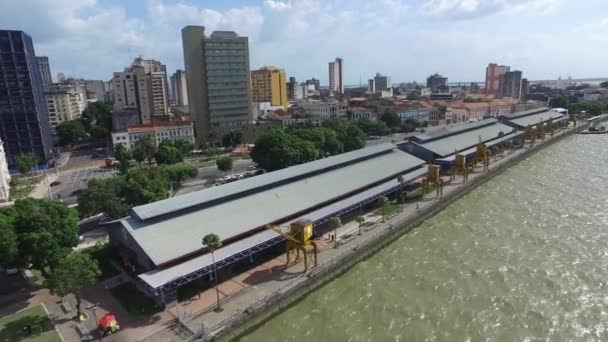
[266,219,319,272]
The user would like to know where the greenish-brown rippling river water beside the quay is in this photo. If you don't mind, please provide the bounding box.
[243,135,608,342]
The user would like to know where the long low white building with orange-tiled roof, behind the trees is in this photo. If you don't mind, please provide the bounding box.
[112,123,194,150]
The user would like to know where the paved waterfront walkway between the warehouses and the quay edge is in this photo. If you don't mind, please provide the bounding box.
[156,127,567,341]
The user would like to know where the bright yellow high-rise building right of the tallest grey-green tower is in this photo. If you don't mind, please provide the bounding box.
[251,66,289,108]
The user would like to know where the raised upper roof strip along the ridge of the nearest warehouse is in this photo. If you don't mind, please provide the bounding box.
[133,143,394,221]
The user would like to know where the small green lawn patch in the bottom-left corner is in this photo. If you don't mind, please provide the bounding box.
[0,305,61,342]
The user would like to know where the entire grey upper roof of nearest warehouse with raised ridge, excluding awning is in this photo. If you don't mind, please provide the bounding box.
[122,144,424,266]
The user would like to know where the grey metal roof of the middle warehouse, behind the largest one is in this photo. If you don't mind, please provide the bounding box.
[410,119,513,157]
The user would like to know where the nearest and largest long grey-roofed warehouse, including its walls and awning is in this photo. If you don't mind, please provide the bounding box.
[110,144,426,305]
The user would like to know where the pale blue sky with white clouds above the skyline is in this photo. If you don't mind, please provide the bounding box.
[0,0,608,85]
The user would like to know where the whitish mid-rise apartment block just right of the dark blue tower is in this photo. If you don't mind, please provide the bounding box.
[44,83,86,129]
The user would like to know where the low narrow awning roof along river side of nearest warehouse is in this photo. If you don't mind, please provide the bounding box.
[139,167,427,288]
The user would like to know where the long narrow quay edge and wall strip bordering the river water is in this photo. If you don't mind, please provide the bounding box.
[193,124,588,341]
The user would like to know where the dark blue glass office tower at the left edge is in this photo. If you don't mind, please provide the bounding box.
[0,30,53,165]
